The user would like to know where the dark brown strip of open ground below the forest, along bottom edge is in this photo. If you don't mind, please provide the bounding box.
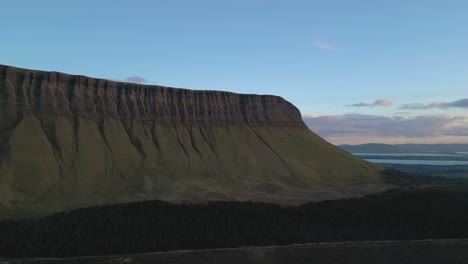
[0,240,468,264]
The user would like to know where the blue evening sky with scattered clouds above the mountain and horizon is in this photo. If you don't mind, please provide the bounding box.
[0,0,468,144]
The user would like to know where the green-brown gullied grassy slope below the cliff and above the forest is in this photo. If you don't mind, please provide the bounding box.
[0,115,389,221]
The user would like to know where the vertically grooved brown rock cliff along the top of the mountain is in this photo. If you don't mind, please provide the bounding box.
[0,65,305,127]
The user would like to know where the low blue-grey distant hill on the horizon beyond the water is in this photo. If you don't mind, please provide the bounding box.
[339,143,468,153]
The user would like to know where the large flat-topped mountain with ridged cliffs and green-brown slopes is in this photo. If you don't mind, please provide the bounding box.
[0,65,391,219]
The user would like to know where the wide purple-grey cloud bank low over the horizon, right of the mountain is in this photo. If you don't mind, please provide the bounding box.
[303,114,468,144]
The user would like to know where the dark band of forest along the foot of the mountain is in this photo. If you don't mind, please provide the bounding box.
[0,187,468,257]
